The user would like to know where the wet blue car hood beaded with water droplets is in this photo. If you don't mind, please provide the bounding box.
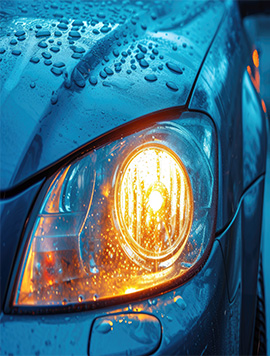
[0,0,225,191]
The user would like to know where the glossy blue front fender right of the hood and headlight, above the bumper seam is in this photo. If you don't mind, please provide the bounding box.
[189,2,267,230]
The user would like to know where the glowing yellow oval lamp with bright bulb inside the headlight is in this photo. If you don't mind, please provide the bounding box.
[116,144,193,268]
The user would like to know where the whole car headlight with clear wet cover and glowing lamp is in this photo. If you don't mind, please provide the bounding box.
[13,114,216,307]
